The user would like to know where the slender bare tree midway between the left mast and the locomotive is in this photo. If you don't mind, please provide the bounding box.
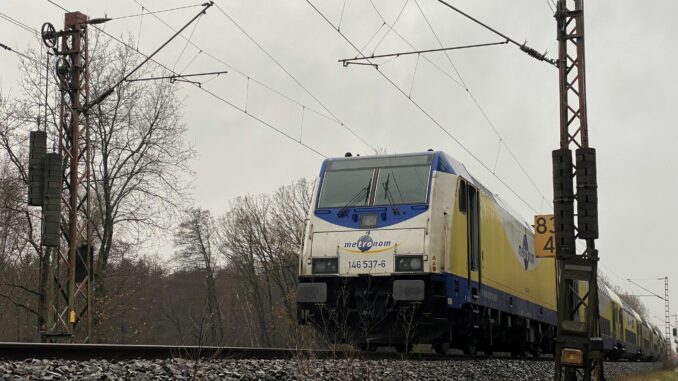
[174,208,224,344]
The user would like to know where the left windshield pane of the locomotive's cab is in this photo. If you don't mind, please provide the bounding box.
[318,168,374,208]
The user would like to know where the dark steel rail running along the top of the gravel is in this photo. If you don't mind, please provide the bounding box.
[0,343,553,361]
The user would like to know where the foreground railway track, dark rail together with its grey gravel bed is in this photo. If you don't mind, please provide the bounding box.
[0,343,658,381]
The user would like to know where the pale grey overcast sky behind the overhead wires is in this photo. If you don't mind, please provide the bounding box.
[0,0,678,323]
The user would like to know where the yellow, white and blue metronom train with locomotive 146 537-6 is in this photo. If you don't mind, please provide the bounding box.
[296,150,665,360]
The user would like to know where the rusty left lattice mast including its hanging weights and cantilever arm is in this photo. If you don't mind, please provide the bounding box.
[33,1,214,342]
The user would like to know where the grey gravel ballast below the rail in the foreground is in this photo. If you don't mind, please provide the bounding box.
[0,359,659,381]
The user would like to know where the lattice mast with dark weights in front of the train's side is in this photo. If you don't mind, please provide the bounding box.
[553,0,604,381]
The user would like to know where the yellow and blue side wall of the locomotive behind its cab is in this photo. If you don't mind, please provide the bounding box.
[447,180,556,324]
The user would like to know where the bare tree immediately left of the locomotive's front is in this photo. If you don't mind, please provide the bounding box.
[219,179,312,345]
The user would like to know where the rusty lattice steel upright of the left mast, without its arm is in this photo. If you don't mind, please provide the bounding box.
[40,12,93,342]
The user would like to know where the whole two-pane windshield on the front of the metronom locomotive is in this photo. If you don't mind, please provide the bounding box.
[318,155,433,208]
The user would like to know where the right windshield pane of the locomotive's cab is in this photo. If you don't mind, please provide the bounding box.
[374,165,431,206]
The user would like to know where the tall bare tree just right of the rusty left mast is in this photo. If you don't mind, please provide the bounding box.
[85,35,194,308]
